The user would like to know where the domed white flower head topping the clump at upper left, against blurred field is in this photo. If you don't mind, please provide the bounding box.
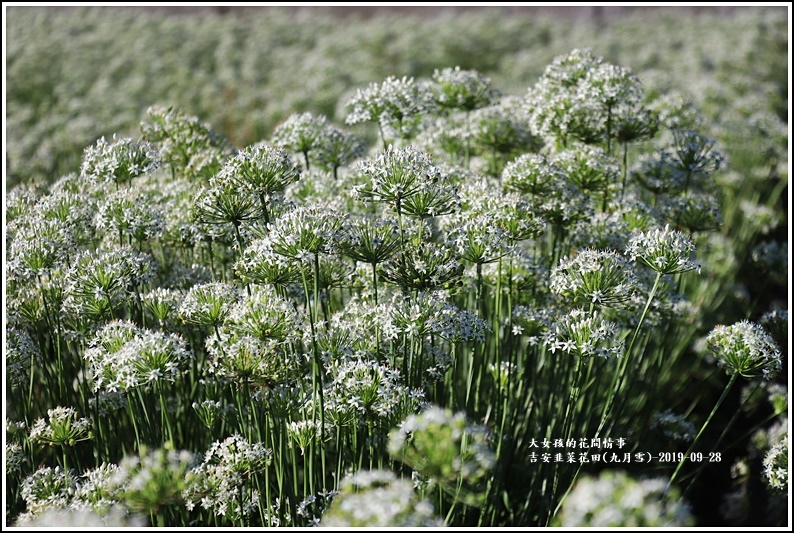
[80,136,160,184]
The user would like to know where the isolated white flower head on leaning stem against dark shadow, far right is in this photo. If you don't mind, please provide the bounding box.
[706,320,782,380]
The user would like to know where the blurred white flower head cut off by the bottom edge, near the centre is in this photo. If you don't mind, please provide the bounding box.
[319,470,443,528]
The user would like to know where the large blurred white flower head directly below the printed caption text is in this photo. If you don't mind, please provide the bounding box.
[554,470,694,528]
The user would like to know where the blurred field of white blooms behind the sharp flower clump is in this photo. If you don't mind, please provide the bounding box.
[6,7,788,187]
